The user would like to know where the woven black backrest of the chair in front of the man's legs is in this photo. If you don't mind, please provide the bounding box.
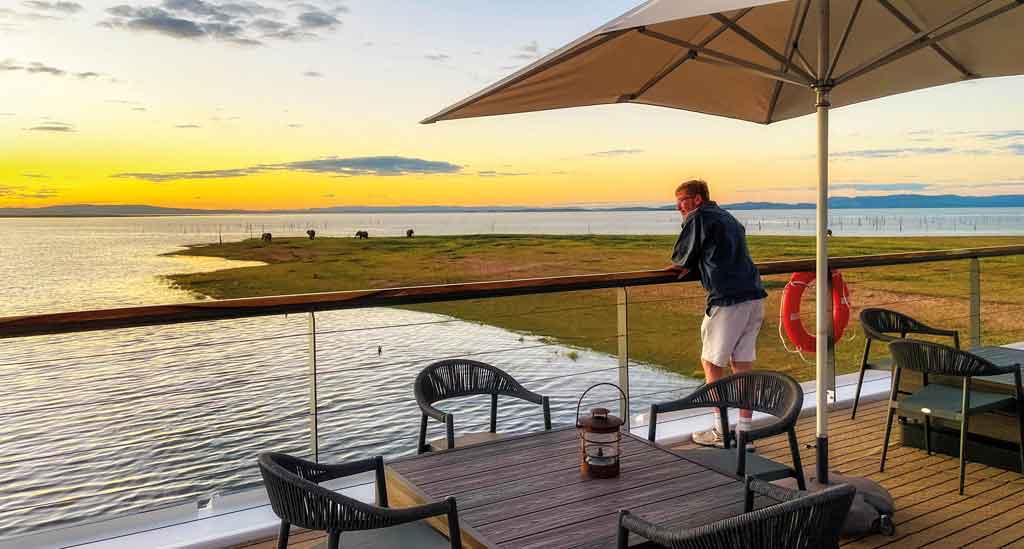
[687,372,804,423]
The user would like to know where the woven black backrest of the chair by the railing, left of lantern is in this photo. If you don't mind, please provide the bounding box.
[414,358,541,405]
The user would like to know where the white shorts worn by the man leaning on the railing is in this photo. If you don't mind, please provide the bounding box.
[700,299,765,368]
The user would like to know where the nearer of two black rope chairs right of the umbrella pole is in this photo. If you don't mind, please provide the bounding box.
[879,339,1024,496]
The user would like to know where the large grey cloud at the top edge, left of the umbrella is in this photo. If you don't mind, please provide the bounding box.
[99,0,348,46]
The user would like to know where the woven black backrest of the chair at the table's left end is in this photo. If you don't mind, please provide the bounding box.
[259,452,391,532]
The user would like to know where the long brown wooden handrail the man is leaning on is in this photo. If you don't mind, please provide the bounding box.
[0,246,1024,339]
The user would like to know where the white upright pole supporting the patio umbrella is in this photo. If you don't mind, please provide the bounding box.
[814,0,831,483]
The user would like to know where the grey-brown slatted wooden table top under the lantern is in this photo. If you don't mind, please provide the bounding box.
[386,427,761,548]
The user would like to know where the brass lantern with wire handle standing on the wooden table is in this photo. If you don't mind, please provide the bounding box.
[577,383,626,478]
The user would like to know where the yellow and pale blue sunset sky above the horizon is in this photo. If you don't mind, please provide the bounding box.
[6,0,1024,209]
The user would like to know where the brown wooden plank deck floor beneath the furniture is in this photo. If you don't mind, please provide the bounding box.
[239,400,1024,549]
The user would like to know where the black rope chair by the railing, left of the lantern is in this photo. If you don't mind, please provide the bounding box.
[414,358,551,454]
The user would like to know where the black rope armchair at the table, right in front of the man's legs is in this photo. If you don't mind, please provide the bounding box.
[647,372,806,490]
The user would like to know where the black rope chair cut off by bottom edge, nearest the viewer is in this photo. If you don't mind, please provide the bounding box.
[617,477,856,549]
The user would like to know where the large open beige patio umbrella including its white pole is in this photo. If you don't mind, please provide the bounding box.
[423,0,1024,481]
